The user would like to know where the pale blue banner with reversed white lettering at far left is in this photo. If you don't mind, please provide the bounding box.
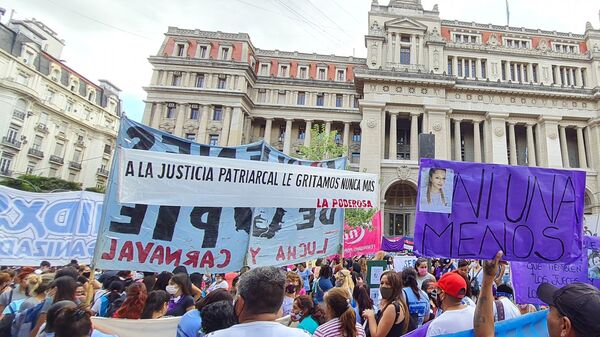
[0,186,102,266]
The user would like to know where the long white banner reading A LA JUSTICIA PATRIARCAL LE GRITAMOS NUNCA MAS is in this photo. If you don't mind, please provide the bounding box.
[117,148,379,208]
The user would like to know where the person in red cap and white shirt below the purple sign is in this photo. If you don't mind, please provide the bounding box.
[427,272,475,337]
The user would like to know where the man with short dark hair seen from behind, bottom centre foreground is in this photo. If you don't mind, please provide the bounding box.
[207,267,309,337]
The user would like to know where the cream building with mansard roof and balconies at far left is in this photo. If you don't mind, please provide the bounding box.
[0,14,121,187]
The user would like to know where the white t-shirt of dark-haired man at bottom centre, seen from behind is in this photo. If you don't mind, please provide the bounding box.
[206,321,310,337]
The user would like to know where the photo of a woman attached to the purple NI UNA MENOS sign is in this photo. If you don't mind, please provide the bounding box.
[419,167,454,213]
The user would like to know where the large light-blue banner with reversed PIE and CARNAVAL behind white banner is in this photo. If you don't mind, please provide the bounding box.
[94,117,346,273]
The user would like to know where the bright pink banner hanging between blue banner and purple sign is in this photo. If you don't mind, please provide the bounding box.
[344,212,381,258]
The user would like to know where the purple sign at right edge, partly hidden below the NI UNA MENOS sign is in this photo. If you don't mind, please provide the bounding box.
[510,236,600,304]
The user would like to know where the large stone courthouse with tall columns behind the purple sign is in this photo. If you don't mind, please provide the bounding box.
[143,0,600,235]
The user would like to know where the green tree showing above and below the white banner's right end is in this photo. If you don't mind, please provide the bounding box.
[298,124,377,228]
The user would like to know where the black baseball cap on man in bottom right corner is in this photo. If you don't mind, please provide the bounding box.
[537,282,600,336]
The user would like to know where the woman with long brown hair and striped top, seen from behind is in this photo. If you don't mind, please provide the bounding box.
[314,288,365,337]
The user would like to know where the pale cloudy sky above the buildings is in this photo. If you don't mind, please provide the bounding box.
[0,0,600,120]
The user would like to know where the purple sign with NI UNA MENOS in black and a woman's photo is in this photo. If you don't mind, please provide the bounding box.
[414,159,585,263]
